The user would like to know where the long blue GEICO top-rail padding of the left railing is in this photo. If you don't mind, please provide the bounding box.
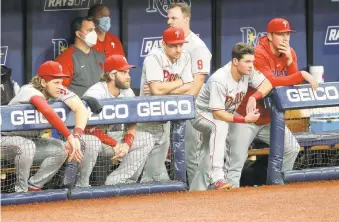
[0,95,195,132]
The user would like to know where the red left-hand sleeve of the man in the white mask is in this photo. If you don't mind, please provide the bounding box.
[54,46,75,87]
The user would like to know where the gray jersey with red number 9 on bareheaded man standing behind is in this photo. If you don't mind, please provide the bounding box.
[183,31,212,75]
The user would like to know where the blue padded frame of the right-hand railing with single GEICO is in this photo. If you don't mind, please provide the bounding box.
[265,82,339,184]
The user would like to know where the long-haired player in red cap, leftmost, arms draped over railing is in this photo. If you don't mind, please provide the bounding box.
[1,61,88,192]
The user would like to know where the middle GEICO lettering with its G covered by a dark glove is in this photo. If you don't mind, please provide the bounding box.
[88,104,128,120]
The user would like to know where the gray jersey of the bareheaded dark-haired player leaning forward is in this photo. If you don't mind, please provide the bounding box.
[196,62,266,113]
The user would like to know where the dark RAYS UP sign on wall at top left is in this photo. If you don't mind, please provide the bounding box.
[44,0,102,11]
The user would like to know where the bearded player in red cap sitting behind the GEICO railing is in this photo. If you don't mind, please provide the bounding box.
[76,55,153,187]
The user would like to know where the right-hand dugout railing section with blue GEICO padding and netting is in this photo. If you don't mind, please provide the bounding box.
[265,82,339,184]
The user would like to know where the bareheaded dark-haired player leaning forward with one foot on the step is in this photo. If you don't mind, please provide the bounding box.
[190,43,272,190]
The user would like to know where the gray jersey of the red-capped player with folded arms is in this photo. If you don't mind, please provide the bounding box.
[140,48,193,96]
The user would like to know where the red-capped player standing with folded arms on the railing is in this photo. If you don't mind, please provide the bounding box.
[139,28,193,182]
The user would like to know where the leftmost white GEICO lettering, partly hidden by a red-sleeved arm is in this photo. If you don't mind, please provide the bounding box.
[11,108,66,126]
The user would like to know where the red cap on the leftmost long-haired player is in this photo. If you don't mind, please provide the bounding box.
[38,61,69,81]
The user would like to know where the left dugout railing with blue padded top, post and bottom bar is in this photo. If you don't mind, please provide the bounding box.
[0,95,195,205]
